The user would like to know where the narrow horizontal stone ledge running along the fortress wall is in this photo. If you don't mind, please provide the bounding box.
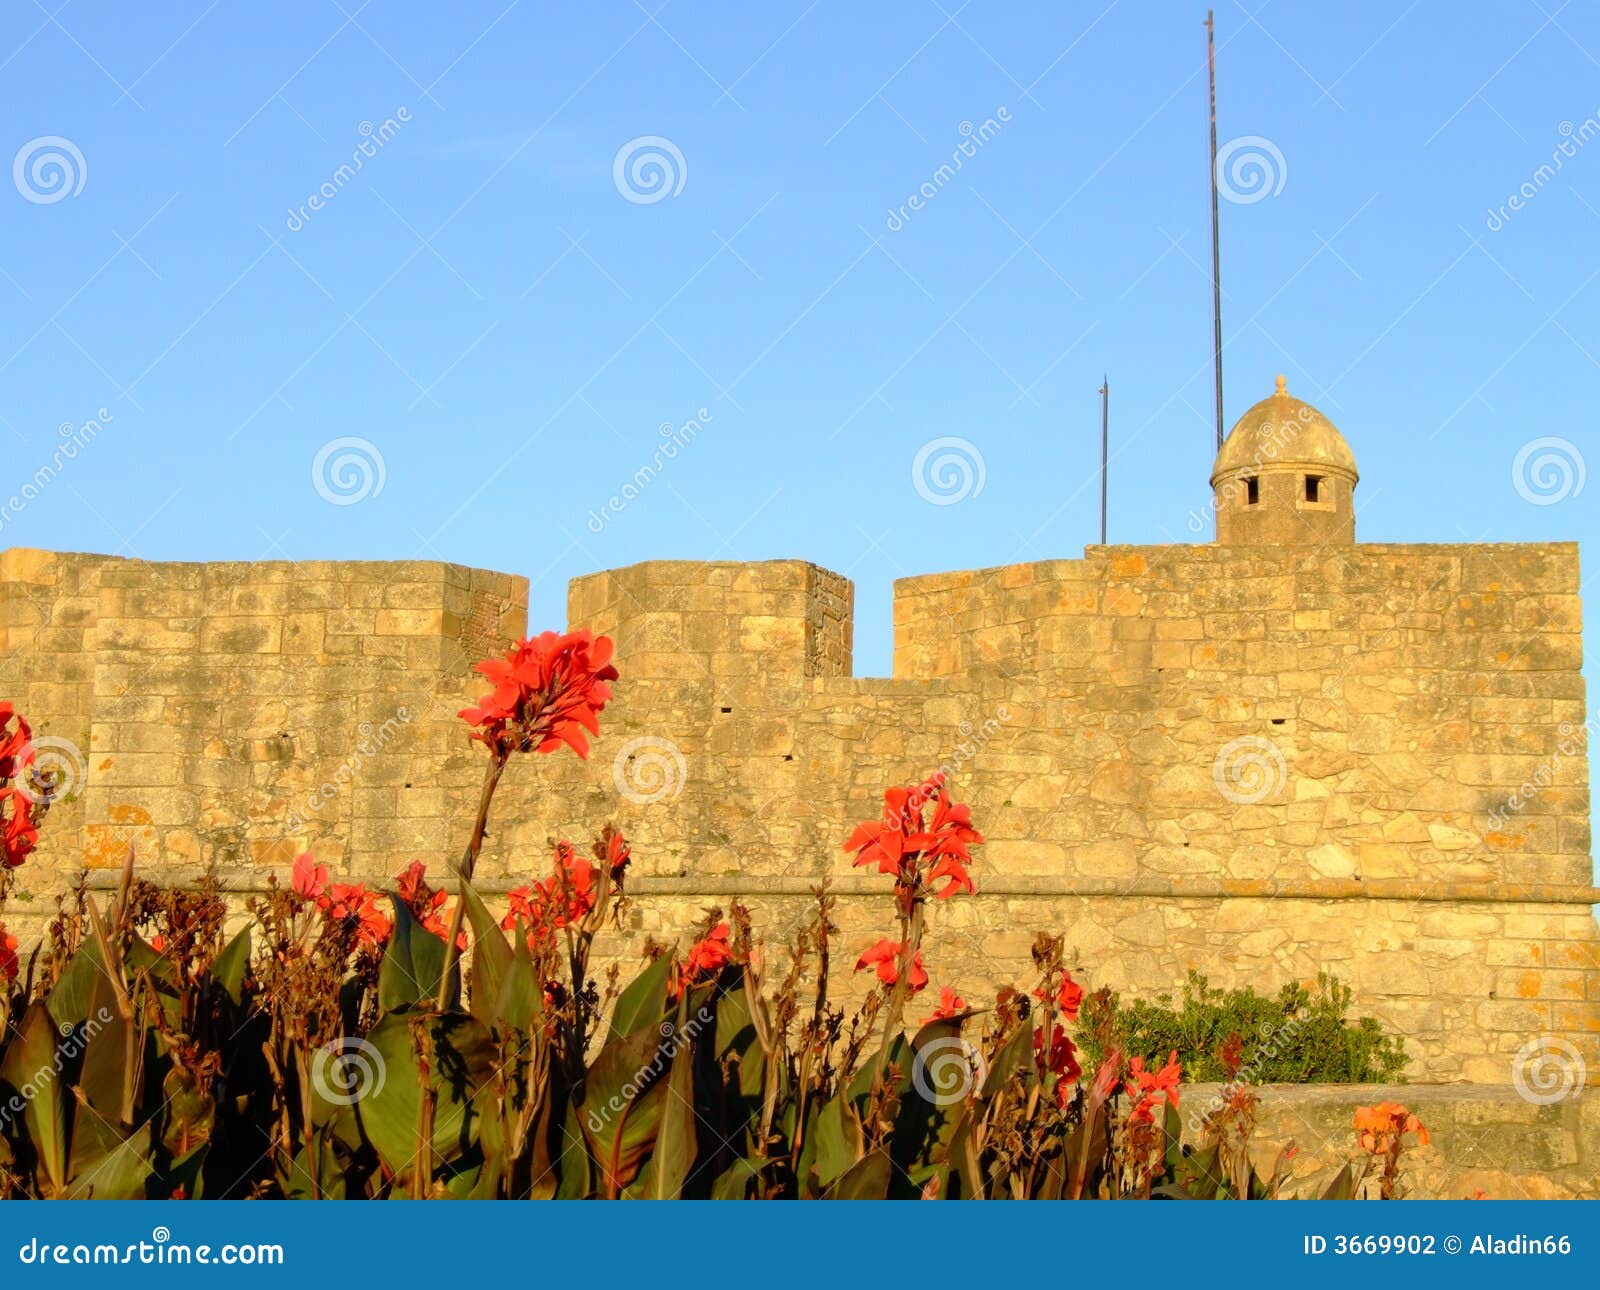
[78,866,1600,909]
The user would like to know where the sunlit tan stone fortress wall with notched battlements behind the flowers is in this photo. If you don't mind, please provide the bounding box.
[0,544,1600,1085]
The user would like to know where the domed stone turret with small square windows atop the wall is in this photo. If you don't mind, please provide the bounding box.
[1211,376,1360,546]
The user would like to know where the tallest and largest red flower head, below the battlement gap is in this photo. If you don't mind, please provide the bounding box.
[461,631,616,757]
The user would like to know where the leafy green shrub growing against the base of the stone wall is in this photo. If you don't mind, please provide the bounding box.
[1080,970,1408,1084]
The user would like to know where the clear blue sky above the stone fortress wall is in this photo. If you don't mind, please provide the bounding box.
[0,0,1600,707]
